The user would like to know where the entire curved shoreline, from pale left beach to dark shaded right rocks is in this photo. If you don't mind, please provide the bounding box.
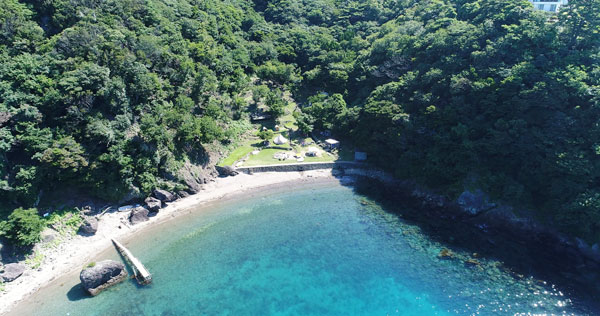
[0,164,600,313]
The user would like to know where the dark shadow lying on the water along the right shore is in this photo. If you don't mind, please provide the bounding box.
[337,173,600,315]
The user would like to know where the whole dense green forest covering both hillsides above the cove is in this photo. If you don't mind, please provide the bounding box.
[0,0,600,242]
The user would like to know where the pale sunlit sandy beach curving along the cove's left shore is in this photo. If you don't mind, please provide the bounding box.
[0,169,335,314]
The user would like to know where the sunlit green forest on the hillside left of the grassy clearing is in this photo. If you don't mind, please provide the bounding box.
[0,0,262,208]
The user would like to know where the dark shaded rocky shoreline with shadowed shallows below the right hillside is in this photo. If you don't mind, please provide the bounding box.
[338,168,600,310]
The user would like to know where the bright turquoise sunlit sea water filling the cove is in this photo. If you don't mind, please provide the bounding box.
[9,184,586,316]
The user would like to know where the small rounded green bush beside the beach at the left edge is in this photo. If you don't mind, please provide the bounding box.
[0,208,46,246]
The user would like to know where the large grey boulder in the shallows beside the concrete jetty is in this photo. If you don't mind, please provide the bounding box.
[79,260,127,296]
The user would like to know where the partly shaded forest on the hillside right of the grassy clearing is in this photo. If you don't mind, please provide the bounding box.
[257,0,600,243]
